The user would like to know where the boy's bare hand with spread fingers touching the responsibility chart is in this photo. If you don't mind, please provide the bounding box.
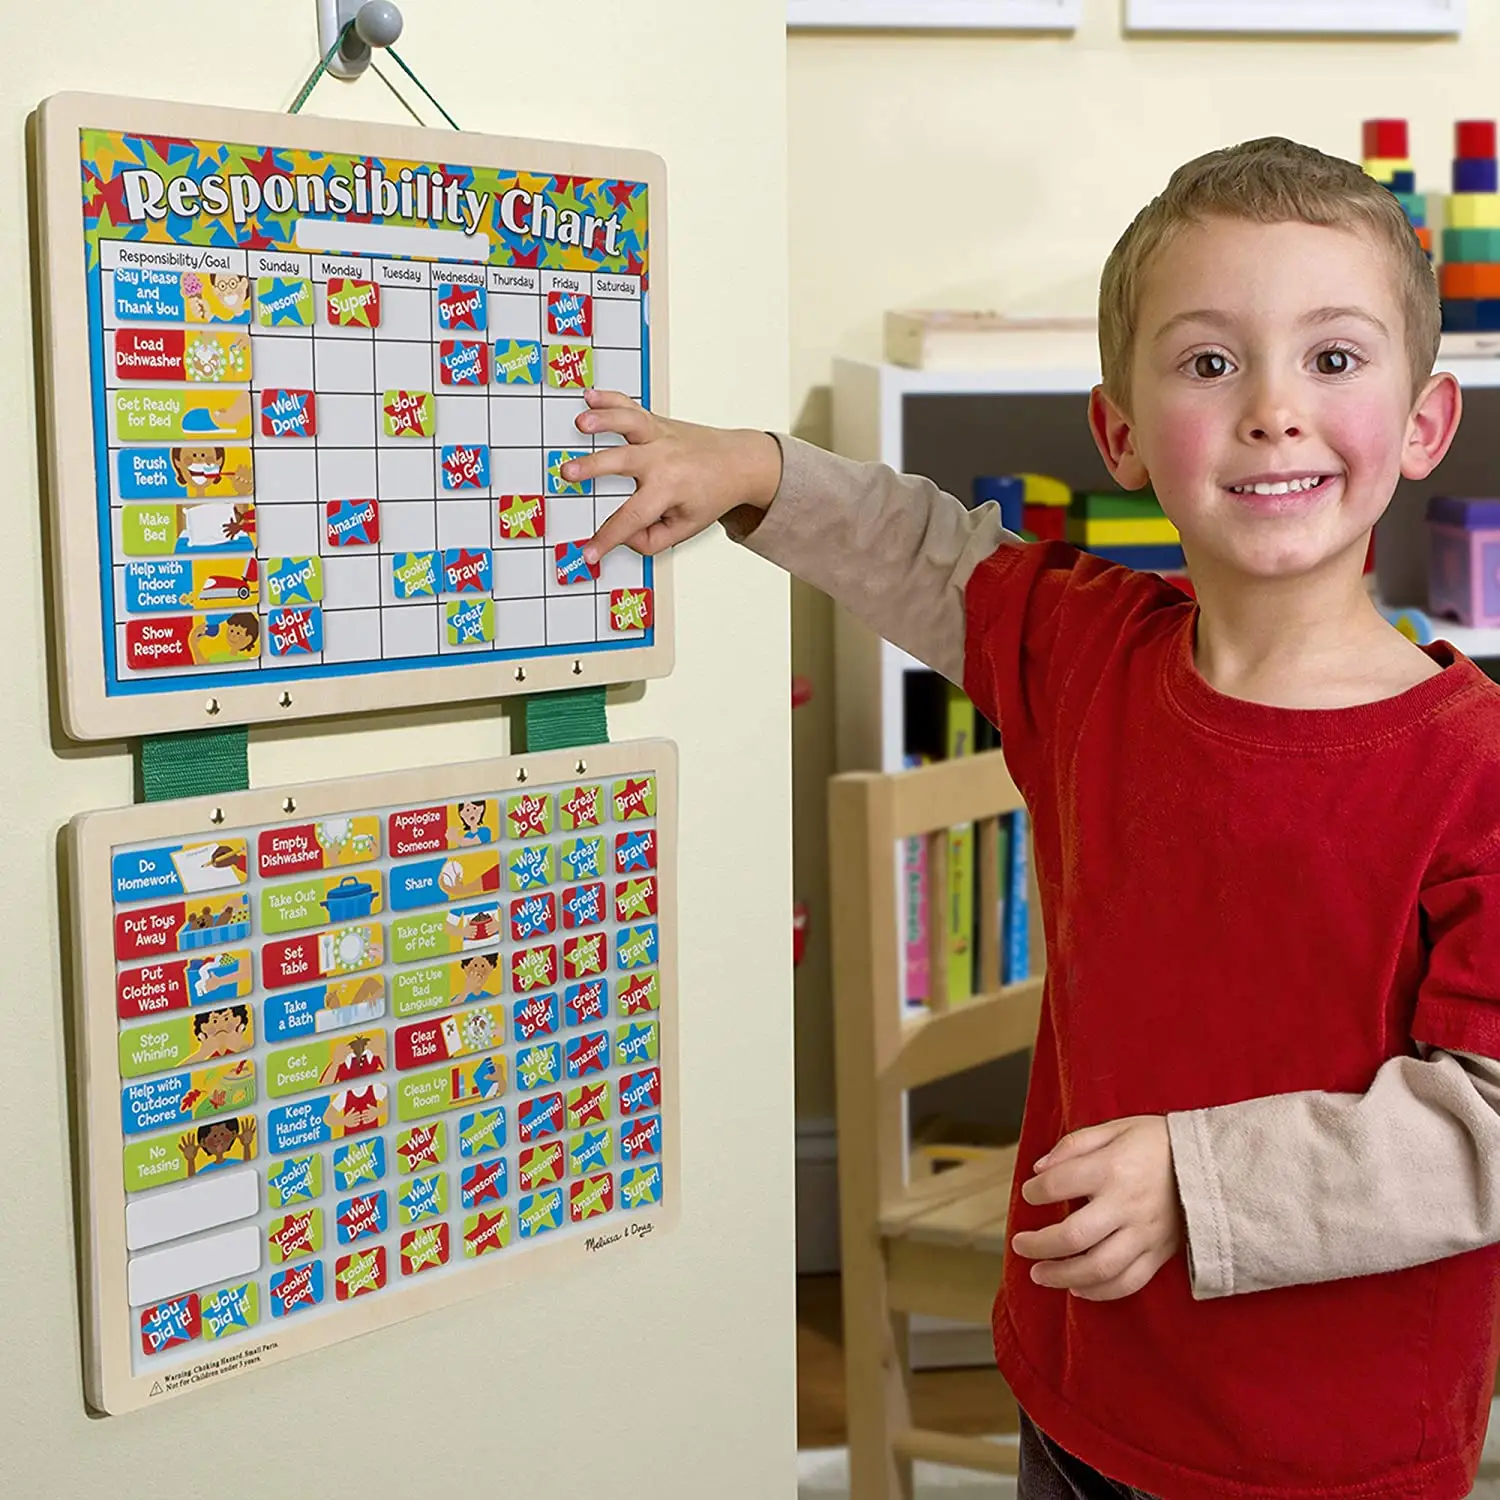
[563,390,782,566]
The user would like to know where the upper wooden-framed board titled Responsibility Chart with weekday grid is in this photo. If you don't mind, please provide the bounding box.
[38,95,672,740]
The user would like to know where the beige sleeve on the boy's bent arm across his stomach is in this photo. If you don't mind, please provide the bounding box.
[1167,1049,1500,1298]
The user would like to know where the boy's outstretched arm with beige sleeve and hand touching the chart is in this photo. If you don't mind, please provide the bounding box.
[564,392,1020,684]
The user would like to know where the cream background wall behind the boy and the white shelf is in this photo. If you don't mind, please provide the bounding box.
[788,0,1500,1118]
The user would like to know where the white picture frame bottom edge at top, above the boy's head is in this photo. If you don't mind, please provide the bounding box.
[1125,0,1467,36]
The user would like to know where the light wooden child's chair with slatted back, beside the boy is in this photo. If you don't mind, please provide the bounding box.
[828,752,1043,1500]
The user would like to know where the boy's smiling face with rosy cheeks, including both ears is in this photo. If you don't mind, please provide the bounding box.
[1091,219,1458,582]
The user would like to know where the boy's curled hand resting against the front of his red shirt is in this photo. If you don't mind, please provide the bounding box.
[1011,1115,1182,1302]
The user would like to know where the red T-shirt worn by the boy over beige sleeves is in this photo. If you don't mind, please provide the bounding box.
[965,543,1500,1500]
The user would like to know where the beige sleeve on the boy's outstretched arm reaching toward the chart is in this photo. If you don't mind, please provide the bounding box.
[725,435,1020,687]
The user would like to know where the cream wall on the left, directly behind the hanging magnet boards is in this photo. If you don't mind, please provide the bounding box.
[0,0,795,1500]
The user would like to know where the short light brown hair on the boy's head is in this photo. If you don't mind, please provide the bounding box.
[1100,135,1442,407]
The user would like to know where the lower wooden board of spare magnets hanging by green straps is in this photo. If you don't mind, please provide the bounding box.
[71,741,678,1413]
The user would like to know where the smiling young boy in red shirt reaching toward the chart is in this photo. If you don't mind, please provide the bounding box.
[572,140,1500,1500]
